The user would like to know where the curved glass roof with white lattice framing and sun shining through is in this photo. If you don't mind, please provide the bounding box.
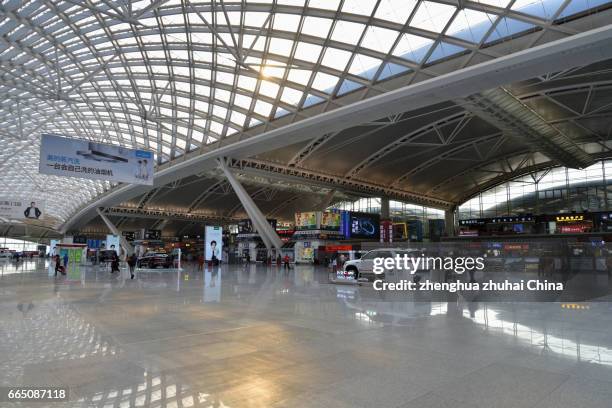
[0,0,612,226]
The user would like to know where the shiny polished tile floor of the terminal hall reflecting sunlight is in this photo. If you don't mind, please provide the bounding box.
[0,260,612,408]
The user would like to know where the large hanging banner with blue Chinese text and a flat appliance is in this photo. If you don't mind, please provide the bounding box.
[39,134,154,185]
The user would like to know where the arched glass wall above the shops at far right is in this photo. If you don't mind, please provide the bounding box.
[459,160,612,219]
